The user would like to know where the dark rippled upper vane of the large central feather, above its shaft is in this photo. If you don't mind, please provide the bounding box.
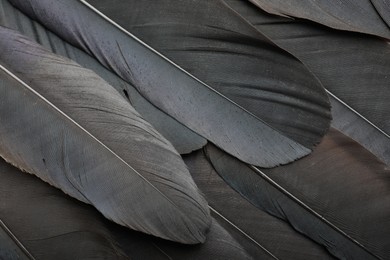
[84,0,329,148]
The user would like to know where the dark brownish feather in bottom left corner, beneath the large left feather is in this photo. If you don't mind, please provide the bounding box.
[0,159,128,259]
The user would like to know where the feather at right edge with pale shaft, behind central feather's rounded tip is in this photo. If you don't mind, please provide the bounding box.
[225,0,390,164]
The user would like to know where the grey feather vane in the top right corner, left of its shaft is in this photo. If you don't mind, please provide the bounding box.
[245,0,390,39]
